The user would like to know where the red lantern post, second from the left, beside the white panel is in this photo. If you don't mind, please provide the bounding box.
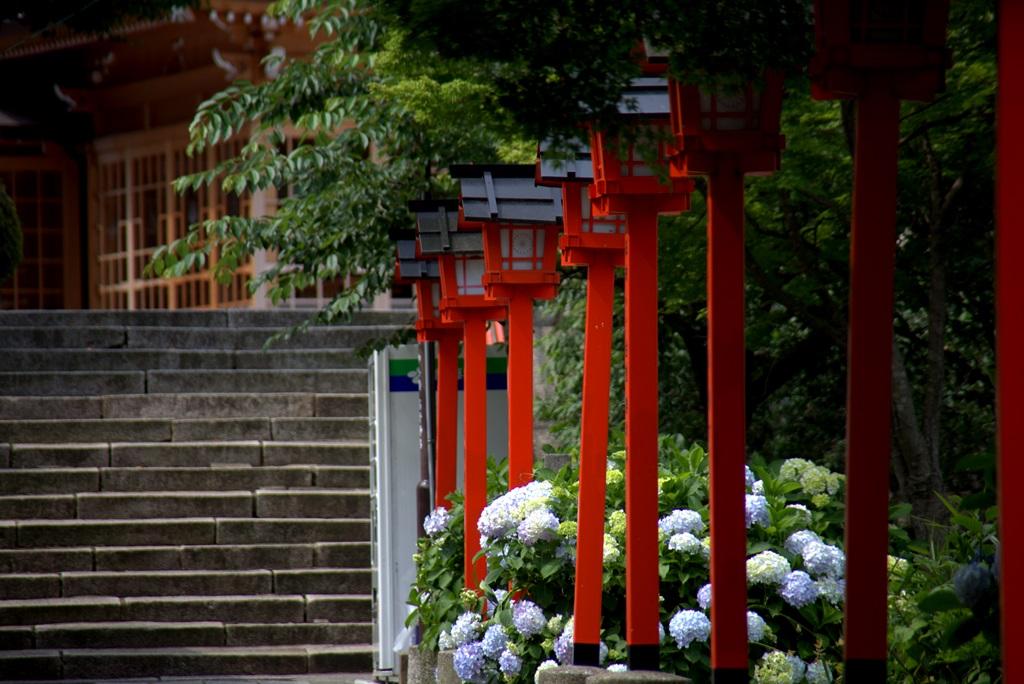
[462,317,487,589]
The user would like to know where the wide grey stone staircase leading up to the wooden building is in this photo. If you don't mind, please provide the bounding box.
[0,310,408,680]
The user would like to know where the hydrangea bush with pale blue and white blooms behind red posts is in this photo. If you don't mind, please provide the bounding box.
[411,437,845,684]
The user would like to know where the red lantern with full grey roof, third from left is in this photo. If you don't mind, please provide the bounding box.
[451,164,562,299]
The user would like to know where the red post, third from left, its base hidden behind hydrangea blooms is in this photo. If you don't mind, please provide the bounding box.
[508,292,534,489]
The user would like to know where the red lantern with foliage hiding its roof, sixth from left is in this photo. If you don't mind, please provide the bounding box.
[669,71,785,176]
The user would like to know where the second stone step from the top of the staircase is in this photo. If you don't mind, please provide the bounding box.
[3,325,408,351]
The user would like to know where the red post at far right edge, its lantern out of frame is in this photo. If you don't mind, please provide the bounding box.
[995,0,1024,684]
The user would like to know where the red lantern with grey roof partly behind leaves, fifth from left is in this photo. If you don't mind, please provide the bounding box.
[588,77,693,215]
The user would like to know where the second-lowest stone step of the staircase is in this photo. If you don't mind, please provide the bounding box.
[0,622,373,650]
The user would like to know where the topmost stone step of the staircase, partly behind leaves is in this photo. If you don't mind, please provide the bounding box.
[0,309,415,328]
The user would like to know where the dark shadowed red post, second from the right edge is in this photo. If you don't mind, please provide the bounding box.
[845,90,899,682]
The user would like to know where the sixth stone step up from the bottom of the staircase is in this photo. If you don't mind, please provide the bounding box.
[6,518,370,549]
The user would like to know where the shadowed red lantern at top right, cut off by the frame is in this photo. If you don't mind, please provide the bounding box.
[809,0,949,100]
